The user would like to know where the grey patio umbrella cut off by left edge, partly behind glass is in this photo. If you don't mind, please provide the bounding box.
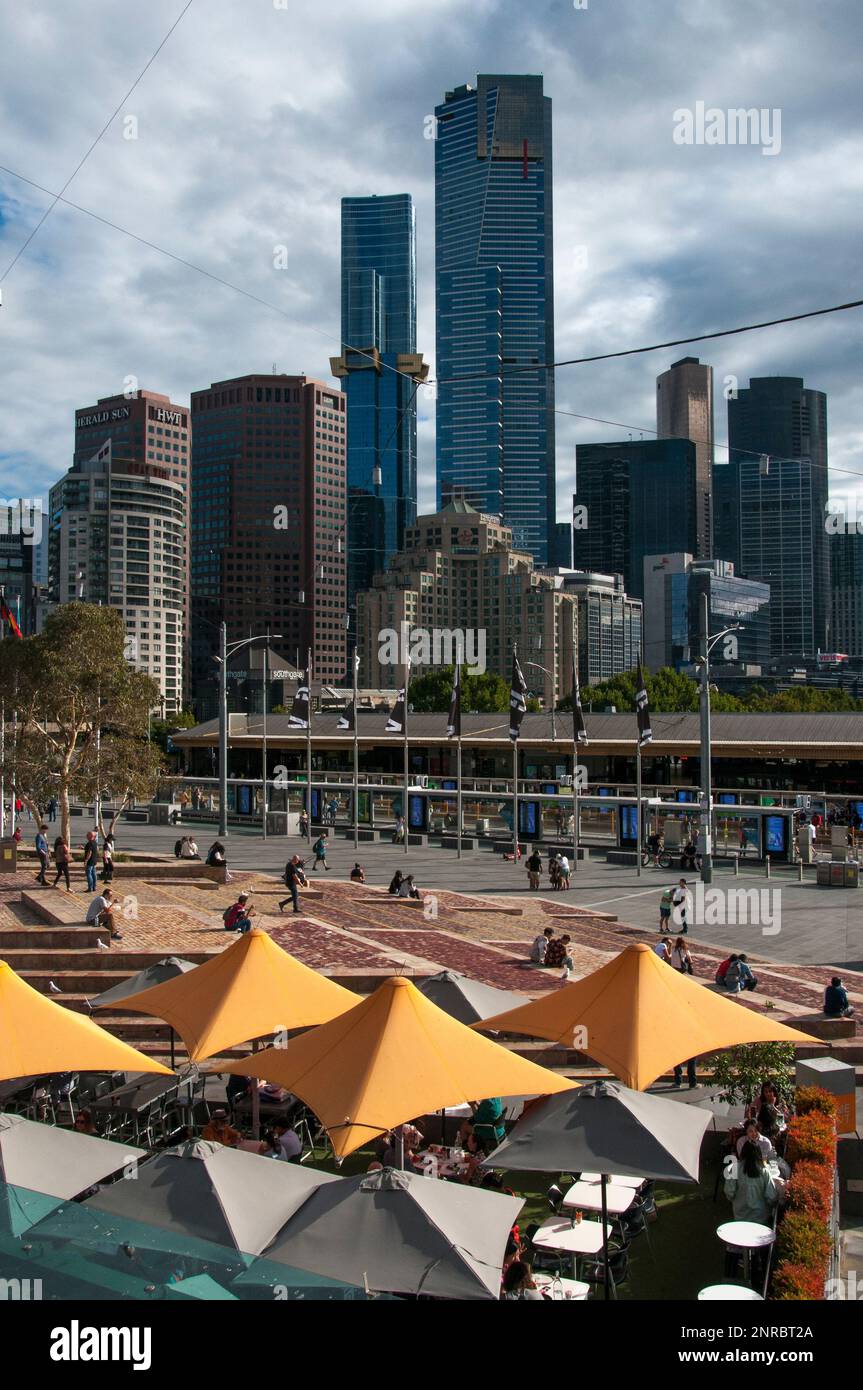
[0,1115,145,1236]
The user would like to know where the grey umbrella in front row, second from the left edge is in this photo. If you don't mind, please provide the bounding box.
[48,1140,340,1255]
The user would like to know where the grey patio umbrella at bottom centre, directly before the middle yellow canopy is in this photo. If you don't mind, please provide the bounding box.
[238,1168,524,1300]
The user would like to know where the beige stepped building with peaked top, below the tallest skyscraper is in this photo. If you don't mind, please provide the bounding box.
[357,499,577,705]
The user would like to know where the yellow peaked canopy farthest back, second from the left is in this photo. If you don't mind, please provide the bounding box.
[96,930,359,1056]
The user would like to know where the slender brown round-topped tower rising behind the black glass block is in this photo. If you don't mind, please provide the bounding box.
[656,357,713,559]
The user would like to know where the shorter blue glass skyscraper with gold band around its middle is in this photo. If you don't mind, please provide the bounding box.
[331,193,428,631]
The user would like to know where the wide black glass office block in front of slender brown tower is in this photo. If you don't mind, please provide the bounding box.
[573,439,698,600]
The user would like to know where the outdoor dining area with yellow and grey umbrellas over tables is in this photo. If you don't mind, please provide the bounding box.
[0,930,835,1301]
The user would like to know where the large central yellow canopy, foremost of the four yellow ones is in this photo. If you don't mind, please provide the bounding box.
[220,976,573,1158]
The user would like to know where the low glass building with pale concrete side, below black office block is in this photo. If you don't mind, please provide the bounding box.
[643,553,770,671]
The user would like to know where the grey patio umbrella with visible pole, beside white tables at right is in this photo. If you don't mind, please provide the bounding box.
[484,1081,710,1298]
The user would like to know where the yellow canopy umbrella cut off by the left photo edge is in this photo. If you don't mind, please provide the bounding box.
[0,960,171,1081]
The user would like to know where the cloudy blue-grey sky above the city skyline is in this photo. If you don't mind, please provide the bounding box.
[0,0,863,516]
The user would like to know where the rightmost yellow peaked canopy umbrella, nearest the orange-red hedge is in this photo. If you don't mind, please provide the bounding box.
[471,942,812,1091]
